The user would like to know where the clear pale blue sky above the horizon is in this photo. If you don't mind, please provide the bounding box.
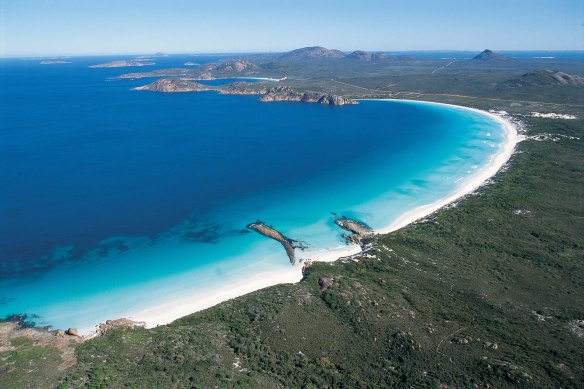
[0,0,584,57]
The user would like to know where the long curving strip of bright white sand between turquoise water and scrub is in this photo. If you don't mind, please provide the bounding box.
[80,99,519,337]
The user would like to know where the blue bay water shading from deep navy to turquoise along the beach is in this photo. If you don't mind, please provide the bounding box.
[0,58,504,329]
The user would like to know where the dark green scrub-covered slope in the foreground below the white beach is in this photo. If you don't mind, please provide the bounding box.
[57,118,584,388]
